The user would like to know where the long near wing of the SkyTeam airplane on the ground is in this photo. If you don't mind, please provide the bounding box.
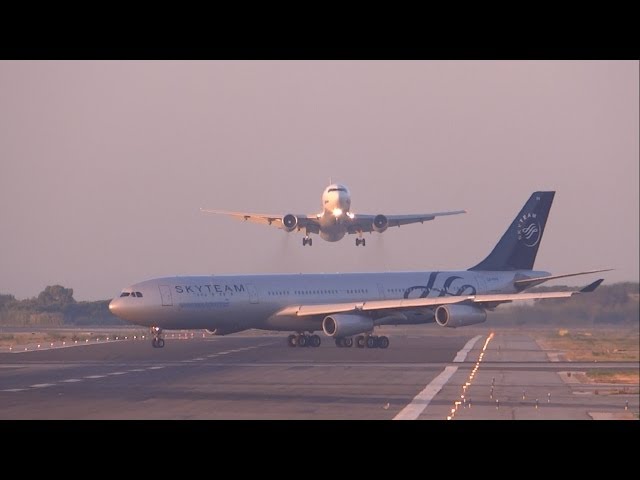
[276,279,603,317]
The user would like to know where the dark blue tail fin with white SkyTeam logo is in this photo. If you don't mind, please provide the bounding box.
[469,192,556,271]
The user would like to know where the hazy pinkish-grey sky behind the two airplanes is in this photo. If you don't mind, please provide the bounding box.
[0,61,639,300]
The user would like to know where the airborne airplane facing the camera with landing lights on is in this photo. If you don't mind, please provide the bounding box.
[200,183,466,247]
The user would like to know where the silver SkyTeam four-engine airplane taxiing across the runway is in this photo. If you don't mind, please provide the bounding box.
[109,192,608,348]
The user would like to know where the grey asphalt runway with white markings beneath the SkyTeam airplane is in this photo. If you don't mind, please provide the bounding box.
[0,332,638,420]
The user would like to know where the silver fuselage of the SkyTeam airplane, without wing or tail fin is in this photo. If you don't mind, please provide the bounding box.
[109,270,548,332]
